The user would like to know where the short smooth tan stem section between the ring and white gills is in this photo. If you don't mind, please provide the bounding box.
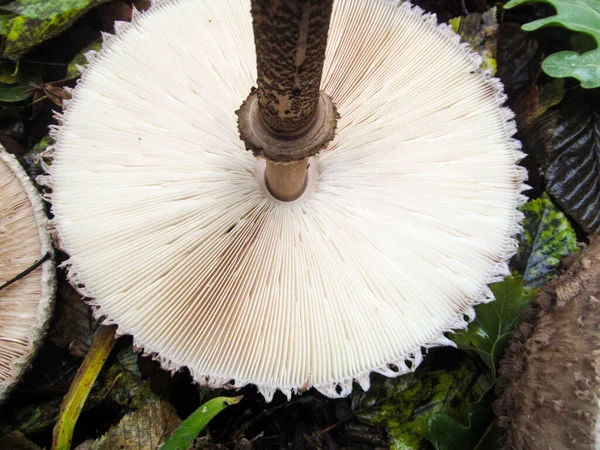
[265,158,308,202]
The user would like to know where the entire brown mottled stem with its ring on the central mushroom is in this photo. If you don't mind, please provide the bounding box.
[237,0,338,201]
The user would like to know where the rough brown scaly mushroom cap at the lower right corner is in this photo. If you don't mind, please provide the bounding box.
[494,237,600,450]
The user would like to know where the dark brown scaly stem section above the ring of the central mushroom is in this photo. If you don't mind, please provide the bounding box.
[252,0,333,133]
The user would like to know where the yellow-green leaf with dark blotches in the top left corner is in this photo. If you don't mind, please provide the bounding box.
[0,0,107,58]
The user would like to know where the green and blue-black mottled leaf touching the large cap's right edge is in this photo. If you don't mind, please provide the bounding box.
[511,194,577,288]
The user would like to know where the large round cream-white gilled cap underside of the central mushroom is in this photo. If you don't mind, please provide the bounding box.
[42,0,526,399]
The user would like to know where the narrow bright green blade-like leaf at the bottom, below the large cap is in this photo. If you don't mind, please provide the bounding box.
[161,397,242,450]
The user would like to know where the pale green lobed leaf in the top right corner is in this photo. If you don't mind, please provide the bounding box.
[504,0,600,89]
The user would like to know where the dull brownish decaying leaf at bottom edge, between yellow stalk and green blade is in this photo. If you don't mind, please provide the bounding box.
[92,401,180,450]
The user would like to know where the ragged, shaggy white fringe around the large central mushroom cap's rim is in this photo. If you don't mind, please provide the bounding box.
[37,0,530,402]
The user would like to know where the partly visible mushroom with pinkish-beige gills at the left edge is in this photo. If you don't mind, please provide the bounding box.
[0,147,56,402]
